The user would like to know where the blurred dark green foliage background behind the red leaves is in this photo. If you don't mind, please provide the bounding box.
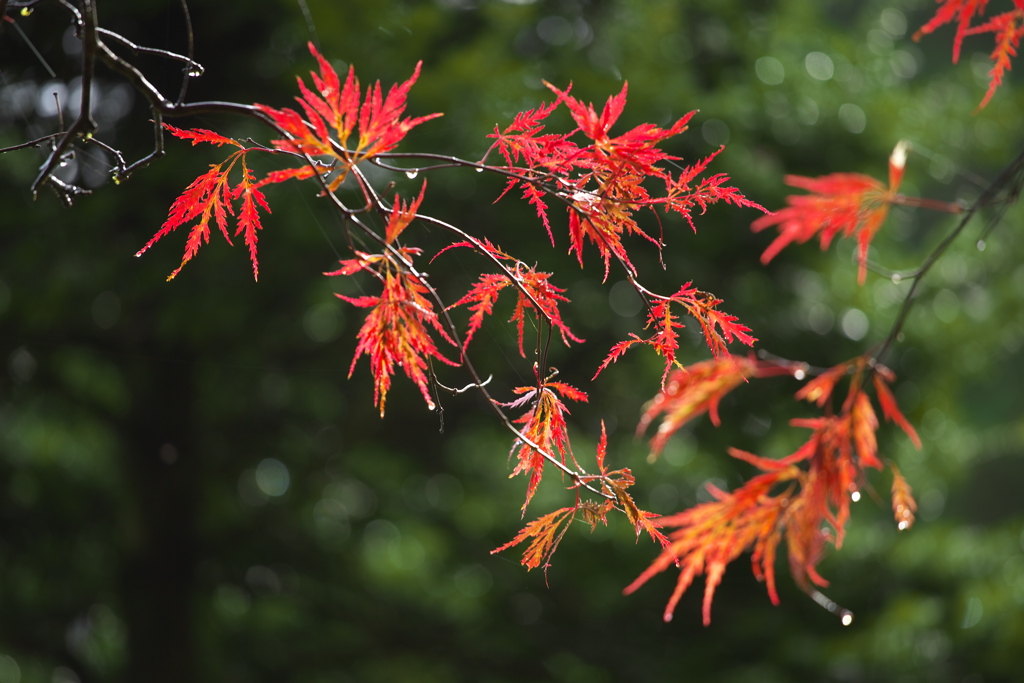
[0,0,1024,683]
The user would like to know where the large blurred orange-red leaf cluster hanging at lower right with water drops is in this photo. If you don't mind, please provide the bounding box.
[626,356,921,625]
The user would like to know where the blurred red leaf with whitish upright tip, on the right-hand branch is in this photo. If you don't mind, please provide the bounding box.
[751,141,907,285]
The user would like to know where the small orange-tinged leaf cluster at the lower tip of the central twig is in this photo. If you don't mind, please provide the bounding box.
[490,422,669,573]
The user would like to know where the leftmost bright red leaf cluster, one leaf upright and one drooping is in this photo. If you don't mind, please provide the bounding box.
[136,43,441,280]
